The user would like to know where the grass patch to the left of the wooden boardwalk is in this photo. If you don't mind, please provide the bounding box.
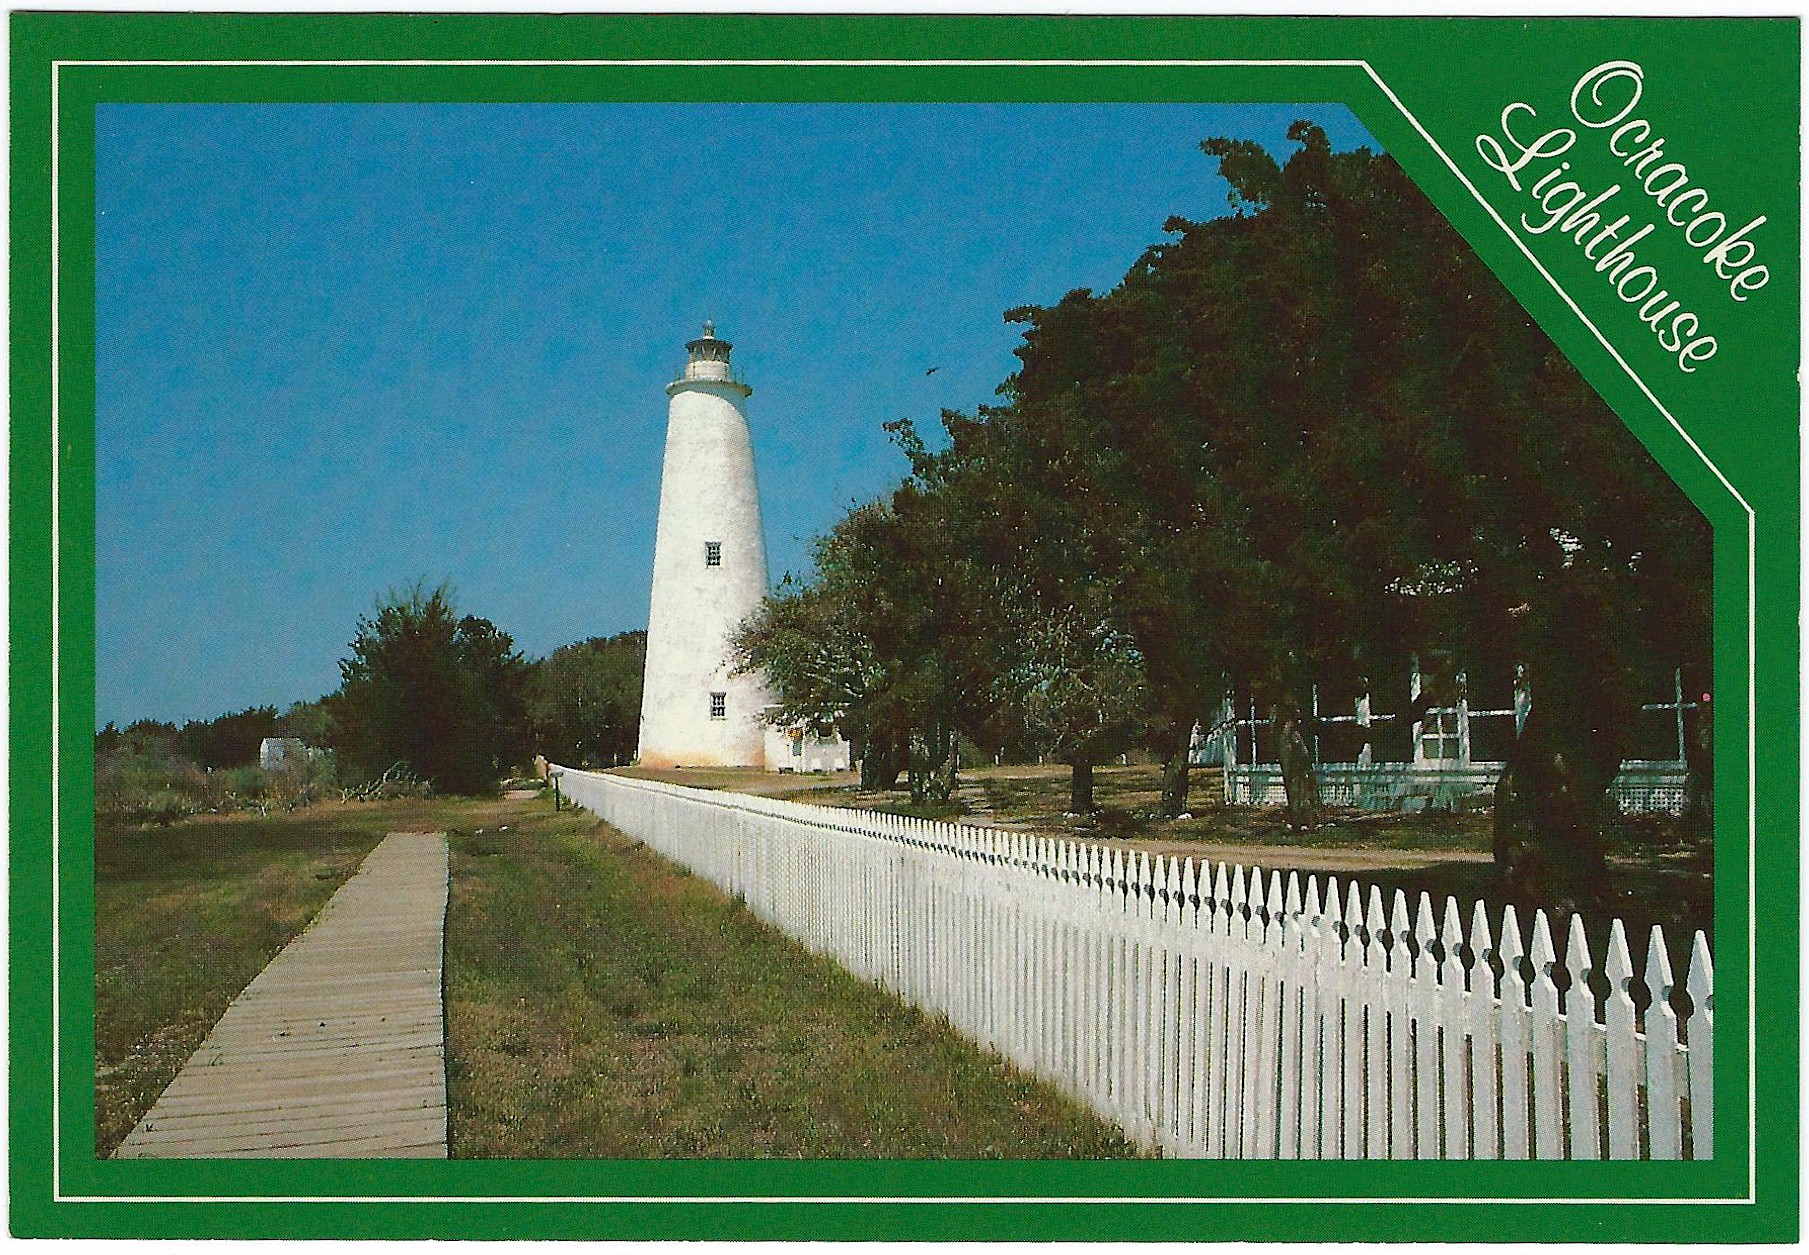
[94,801,524,1157]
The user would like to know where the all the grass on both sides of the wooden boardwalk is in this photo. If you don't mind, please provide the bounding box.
[94,797,1134,1157]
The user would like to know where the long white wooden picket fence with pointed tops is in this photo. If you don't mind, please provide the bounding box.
[555,769,1715,1159]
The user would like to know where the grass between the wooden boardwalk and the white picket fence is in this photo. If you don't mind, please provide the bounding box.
[447,801,1134,1159]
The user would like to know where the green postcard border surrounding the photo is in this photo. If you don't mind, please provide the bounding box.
[9,13,1800,1241]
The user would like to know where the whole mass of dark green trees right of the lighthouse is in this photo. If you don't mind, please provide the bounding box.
[751,123,1711,892]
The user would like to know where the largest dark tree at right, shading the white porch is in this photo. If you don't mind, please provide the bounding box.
[998,123,1711,904]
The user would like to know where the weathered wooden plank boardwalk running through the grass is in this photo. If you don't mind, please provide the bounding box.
[116,832,447,1159]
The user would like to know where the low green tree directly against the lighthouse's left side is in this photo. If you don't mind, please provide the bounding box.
[528,631,648,767]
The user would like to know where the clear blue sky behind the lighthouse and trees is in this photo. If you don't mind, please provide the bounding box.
[96,105,1377,723]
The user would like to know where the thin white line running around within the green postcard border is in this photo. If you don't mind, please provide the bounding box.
[51,58,1758,1206]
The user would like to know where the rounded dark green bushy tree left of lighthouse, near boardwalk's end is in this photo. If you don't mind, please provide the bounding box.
[326,584,526,794]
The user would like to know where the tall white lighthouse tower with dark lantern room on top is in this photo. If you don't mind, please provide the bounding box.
[640,322,771,767]
